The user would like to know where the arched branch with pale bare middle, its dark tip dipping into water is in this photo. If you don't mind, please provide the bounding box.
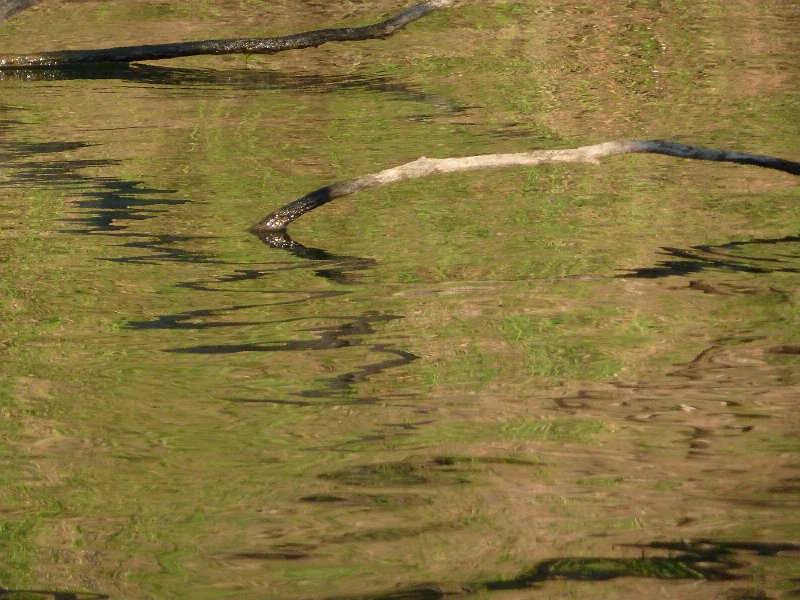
[250,140,800,233]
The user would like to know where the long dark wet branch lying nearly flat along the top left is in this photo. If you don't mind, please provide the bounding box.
[0,0,458,69]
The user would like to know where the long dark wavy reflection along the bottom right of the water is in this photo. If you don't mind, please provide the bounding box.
[326,540,800,600]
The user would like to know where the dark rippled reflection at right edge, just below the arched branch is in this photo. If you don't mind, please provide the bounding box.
[618,235,800,279]
